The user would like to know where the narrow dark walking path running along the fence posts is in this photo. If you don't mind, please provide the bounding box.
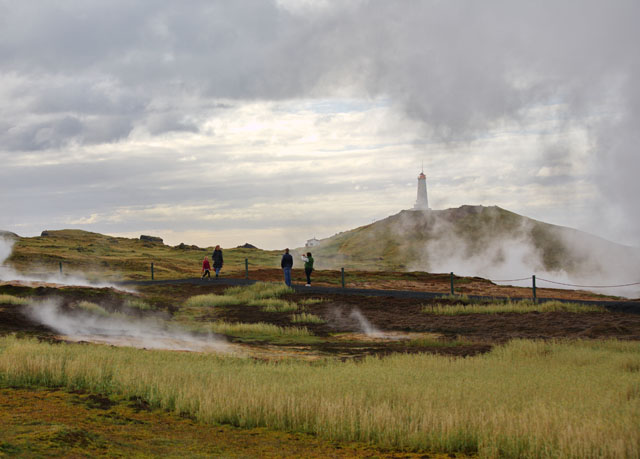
[118,277,640,314]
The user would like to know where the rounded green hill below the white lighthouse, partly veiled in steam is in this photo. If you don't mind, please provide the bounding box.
[298,206,640,276]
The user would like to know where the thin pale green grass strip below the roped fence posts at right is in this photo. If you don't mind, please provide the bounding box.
[422,300,606,316]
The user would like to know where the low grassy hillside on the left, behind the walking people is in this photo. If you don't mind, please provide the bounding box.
[6,230,281,280]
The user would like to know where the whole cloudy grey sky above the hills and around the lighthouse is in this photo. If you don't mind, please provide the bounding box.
[0,0,640,252]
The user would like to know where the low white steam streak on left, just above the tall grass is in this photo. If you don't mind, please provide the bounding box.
[25,299,231,353]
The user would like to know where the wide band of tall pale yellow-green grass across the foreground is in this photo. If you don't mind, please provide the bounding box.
[0,337,640,458]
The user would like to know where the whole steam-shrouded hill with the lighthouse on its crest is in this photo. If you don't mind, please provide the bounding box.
[316,206,640,297]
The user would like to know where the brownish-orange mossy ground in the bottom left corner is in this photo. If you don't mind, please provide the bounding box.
[0,388,462,458]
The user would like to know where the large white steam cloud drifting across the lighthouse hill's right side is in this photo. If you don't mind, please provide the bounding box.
[410,208,640,296]
